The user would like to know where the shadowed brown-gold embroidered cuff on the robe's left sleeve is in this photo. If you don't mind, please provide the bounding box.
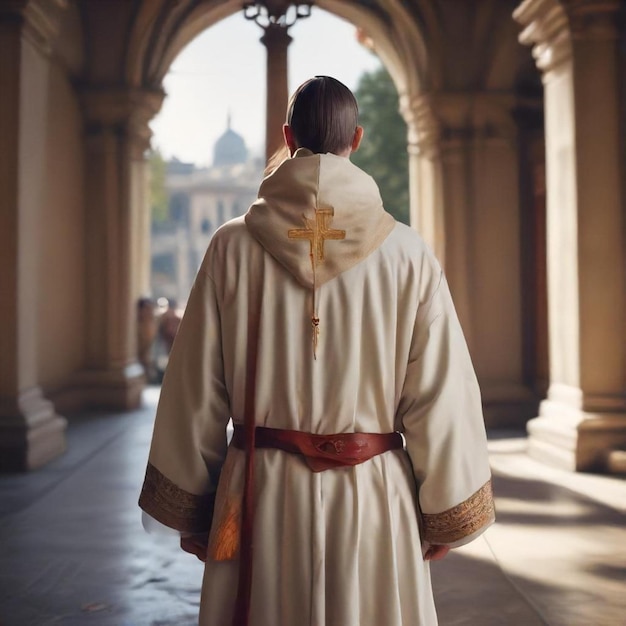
[139,463,215,533]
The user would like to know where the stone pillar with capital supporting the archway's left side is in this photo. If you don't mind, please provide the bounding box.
[80,89,163,409]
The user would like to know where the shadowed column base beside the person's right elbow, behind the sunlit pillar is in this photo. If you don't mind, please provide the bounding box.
[481,383,539,429]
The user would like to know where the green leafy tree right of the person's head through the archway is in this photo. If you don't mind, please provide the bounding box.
[351,66,409,224]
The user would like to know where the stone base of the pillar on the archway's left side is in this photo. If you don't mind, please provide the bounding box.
[76,363,146,411]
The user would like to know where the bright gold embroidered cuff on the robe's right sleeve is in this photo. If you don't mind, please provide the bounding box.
[422,480,495,544]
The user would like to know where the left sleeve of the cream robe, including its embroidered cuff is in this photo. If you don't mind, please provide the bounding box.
[139,269,230,533]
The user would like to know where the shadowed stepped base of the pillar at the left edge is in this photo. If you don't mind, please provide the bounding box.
[0,387,67,472]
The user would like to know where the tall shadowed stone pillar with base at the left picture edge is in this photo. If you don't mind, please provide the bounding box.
[0,2,66,470]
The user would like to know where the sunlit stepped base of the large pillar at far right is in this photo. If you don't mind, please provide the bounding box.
[527,400,626,473]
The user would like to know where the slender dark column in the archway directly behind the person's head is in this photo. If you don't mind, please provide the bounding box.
[261,22,291,162]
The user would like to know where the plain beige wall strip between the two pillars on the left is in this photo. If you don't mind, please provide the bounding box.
[37,62,85,391]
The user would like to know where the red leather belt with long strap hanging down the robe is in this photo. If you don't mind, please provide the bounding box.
[231,424,404,626]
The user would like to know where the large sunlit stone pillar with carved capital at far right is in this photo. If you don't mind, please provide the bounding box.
[514,0,626,471]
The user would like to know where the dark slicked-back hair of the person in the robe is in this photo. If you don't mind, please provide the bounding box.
[287,76,359,154]
